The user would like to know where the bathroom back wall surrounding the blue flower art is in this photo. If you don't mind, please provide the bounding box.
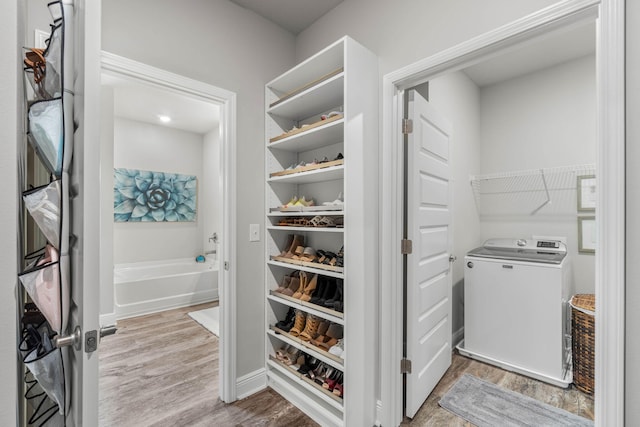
[113,117,203,264]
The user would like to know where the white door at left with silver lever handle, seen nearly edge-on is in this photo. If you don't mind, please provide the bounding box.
[64,0,101,427]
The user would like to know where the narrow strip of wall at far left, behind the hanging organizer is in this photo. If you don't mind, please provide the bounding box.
[0,1,20,426]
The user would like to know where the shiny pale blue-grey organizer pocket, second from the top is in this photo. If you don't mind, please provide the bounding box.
[29,98,64,176]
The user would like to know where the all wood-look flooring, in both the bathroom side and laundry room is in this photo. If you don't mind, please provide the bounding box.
[99,303,593,427]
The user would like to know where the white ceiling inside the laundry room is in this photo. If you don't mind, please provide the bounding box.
[464,23,596,87]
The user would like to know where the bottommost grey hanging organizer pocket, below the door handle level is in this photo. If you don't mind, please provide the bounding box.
[19,328,65,413]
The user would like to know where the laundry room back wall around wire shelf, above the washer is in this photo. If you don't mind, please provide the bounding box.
[478,56,597,293]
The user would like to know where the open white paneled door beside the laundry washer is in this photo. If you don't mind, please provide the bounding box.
[405,90,451,418]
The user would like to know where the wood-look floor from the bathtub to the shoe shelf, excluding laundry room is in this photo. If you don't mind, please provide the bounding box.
[99,303,317,427]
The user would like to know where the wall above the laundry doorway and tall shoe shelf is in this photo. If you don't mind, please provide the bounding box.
[296,0,557,75]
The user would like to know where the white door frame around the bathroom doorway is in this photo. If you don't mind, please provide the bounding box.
[100,51,237,403]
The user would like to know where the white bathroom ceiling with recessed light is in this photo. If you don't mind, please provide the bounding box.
[102,74,220,134]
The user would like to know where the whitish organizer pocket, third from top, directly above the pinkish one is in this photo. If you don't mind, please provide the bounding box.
[22,180,61,249]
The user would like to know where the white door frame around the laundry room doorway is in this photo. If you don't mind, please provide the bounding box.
[379,0,625,426]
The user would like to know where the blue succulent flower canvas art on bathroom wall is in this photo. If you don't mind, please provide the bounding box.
[113,168,197,222]
